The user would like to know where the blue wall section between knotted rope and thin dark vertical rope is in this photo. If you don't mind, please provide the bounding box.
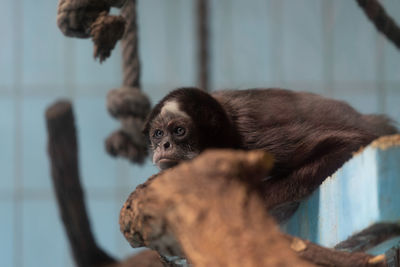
[138,0,196,92]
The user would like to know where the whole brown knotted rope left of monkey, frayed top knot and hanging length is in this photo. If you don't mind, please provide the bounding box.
[57,0,151,163]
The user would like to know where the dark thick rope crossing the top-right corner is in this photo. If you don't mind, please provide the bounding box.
[356,0,400,49]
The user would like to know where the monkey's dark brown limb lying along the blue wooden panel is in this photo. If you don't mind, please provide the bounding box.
[262,131,375,208]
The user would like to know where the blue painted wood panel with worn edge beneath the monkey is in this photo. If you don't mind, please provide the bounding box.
[283,137,400,252]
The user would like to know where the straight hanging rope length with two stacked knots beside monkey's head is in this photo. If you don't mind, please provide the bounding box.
[106,0,151,163]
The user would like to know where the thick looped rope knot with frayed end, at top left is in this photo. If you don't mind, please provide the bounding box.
[57,0,126,62]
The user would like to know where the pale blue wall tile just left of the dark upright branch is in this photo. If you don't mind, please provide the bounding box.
[22,96,59,189]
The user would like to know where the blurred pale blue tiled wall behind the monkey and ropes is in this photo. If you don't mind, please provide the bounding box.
[0,0,400,267]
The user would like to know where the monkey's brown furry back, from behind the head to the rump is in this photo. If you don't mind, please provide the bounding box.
[213,89,397,180]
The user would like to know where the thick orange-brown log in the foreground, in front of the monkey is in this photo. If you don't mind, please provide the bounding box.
[120,151,385,267]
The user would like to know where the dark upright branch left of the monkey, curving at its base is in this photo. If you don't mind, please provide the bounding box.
[46,101,164,267]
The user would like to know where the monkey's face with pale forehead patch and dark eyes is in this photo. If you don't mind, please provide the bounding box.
[148,101,200,170]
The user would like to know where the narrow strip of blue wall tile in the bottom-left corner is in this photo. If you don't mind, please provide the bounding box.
[0,201,16,266]
